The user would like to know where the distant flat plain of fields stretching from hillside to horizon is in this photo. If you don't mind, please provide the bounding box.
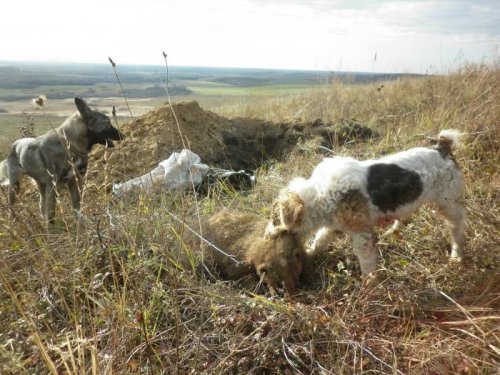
[0,62,410,150]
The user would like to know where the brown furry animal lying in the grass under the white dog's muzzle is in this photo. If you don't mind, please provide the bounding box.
[183,210,305,294]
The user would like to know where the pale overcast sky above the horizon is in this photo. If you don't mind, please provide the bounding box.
[0,0,500,73]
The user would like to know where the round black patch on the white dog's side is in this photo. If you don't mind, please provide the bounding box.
[368,164,423,212]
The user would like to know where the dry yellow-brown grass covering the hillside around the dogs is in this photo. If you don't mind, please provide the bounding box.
[0,66,500,374]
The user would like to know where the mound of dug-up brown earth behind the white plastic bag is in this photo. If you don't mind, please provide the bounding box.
[88,101,373,189]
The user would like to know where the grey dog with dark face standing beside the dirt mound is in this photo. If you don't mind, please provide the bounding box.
[0,98,124,227]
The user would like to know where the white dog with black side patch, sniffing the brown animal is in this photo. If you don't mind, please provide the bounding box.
[266,130,465,276]
